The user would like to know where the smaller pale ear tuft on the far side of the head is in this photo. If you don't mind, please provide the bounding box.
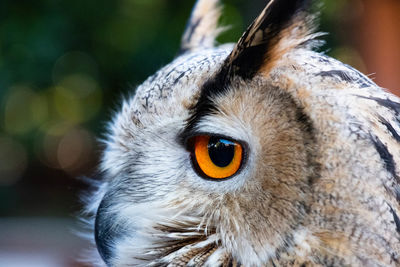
[180,0,223,54]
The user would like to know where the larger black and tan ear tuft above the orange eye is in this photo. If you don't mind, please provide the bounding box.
[225,0,319,79]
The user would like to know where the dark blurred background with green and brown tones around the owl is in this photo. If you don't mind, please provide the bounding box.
[0,0,400,266]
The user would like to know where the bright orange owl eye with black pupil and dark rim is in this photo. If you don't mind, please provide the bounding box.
[189,135,243,179]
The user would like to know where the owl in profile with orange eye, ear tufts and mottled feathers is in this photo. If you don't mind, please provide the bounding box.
[87,0,400,267]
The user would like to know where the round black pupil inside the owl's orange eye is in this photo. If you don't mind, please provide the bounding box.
[208,137,235,168]
